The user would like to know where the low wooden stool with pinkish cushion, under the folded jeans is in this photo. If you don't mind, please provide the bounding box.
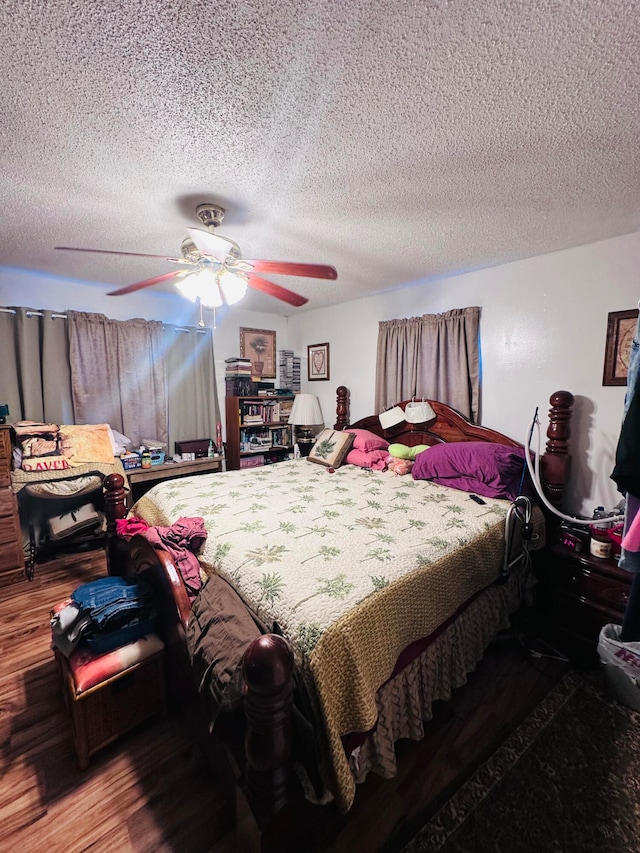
[54,634,166,770]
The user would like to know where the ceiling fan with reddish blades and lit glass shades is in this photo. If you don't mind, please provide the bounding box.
[55,203,338,308]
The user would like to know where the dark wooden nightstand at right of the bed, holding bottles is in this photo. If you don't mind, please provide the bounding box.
[534,544,631,664]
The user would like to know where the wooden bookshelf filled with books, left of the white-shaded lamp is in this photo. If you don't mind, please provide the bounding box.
[225,395,293,471]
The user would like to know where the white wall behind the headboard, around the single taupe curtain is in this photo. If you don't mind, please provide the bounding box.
[289,233,640,514]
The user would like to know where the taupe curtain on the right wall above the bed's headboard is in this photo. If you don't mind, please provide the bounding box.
[375,307,480,423]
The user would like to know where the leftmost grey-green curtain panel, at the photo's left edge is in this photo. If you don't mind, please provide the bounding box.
[0,308,73,424]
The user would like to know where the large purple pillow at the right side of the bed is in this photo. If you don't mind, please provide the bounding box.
[411,441,525,500]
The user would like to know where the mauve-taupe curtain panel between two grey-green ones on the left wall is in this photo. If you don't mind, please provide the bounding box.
[68,311,168,448]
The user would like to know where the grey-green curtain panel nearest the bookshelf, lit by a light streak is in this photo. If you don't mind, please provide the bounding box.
[163,325,220,455]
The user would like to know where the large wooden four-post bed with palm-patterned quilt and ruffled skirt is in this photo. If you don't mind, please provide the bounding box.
[105,386,573,823]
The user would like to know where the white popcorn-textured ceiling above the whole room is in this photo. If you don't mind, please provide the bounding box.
[0,0,640,314]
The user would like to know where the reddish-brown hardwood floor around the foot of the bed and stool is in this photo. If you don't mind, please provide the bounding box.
[0,552,566,853]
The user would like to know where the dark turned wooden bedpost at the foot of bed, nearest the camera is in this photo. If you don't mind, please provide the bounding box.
[242,634,293,825]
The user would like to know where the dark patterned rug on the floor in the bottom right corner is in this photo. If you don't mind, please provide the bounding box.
[404,672,640,853]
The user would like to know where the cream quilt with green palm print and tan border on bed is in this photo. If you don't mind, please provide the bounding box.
[132,459,540,807]
